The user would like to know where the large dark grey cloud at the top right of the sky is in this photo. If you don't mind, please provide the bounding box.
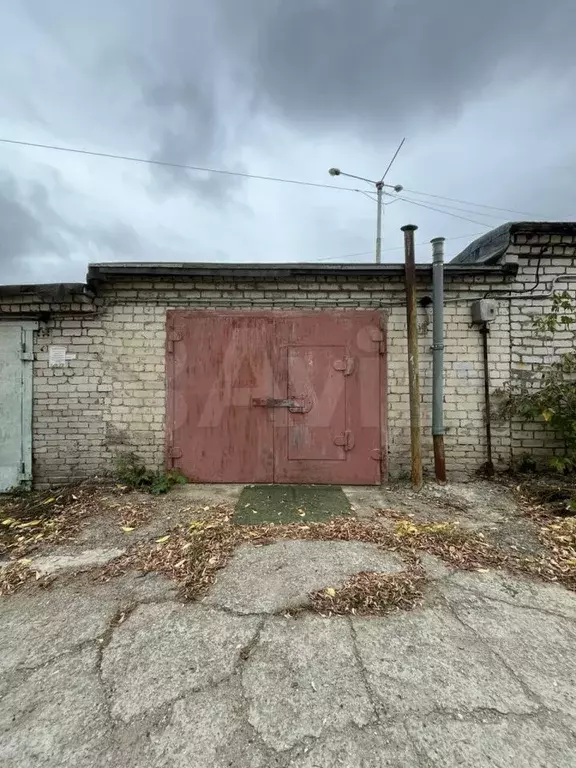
[223,0,576,138]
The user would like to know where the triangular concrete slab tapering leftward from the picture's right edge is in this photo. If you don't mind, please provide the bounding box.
[447,593,576,722]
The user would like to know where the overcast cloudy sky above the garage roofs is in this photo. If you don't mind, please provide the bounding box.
[0,0,576,283]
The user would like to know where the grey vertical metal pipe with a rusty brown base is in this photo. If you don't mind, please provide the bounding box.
[430,237,446,483]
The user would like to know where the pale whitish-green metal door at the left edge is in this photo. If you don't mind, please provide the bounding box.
[0,322,33,492]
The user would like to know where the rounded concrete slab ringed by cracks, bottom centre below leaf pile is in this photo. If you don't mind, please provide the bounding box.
[242,615,374,751]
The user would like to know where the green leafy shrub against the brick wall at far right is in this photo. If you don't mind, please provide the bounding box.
[499,291,576,472]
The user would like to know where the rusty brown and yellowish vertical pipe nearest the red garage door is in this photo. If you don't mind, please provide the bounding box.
[401,224,422,490]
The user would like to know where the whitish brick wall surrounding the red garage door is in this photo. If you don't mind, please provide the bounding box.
[0,226,576,484]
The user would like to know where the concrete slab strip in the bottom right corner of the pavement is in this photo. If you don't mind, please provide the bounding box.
[407,713,576,768]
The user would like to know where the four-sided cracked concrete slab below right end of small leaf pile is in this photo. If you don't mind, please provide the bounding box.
[352,607,538,717]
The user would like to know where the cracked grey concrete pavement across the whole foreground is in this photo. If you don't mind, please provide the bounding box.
[0,542,576,768]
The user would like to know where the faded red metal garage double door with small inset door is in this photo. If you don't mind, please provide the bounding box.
[167,310,385,484]
